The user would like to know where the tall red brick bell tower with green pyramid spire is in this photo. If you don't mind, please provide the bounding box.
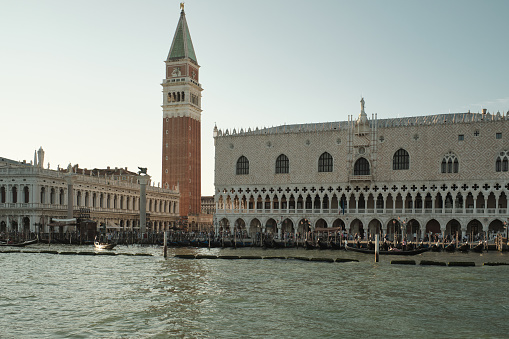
[162,3,203,216]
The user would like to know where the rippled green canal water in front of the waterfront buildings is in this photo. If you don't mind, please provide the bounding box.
[0,244,509,338]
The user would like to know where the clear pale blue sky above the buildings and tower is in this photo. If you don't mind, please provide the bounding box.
[0,0,509,195]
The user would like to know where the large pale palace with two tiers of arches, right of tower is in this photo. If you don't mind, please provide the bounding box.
[214,99,509,238]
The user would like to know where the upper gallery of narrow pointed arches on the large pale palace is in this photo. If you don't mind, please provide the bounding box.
[216,191,508,213]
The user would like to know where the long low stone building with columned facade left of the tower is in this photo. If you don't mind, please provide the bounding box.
[0,148,180,232]
